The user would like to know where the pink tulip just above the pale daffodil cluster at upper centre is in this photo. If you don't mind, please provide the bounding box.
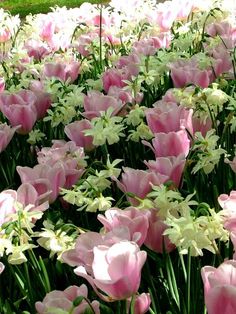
[83,91,123,120]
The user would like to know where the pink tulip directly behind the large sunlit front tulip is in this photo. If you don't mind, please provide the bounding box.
[97,207,148,246]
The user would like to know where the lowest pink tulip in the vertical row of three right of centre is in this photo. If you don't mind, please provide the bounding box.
[144,155,186,187]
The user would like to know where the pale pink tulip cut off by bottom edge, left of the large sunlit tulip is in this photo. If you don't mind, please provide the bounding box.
[35,284,100,314]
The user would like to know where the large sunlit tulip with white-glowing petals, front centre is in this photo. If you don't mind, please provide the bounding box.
[74,241,147,301]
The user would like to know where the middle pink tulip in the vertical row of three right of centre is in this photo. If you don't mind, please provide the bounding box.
[148,130,190,157]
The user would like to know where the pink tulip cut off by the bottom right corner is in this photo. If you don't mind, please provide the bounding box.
[201,260,236,314]
